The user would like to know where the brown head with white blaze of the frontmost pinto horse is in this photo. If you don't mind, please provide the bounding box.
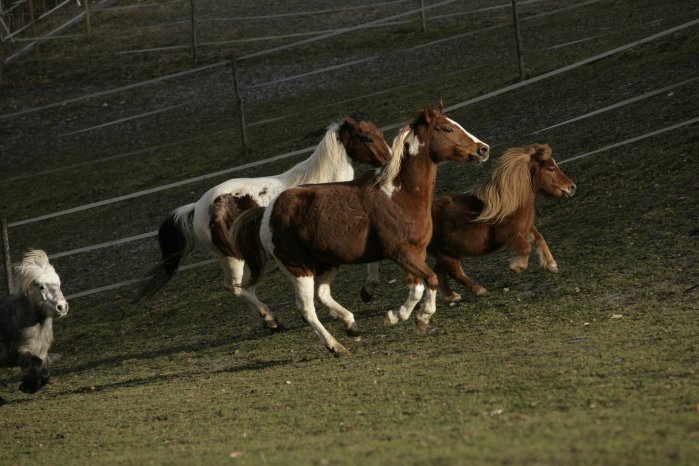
[413,100,490,163]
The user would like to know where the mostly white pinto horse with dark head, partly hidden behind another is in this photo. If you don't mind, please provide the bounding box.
[135,114,391,330]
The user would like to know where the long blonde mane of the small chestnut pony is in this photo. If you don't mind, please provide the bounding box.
[471,145,550,223]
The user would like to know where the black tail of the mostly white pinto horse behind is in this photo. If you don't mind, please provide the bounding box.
[134,204,195,303]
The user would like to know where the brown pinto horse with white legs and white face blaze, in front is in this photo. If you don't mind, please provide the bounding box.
[232,102,489,355]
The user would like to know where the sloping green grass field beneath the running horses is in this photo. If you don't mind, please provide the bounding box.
[0,0,699,465]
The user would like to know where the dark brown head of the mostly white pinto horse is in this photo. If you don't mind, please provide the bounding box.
[338,114,391,167]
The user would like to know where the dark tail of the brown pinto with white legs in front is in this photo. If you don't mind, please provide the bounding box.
[230,207,265,288]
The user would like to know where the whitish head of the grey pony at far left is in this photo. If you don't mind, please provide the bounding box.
[17,250,68,317]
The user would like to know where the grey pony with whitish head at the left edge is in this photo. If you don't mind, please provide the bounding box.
[0,249,68,401]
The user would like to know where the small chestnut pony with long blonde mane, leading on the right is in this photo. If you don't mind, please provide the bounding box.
[427,144,576,302]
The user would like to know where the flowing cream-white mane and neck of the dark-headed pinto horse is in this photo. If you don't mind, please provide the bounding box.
[279,123,354,186]
